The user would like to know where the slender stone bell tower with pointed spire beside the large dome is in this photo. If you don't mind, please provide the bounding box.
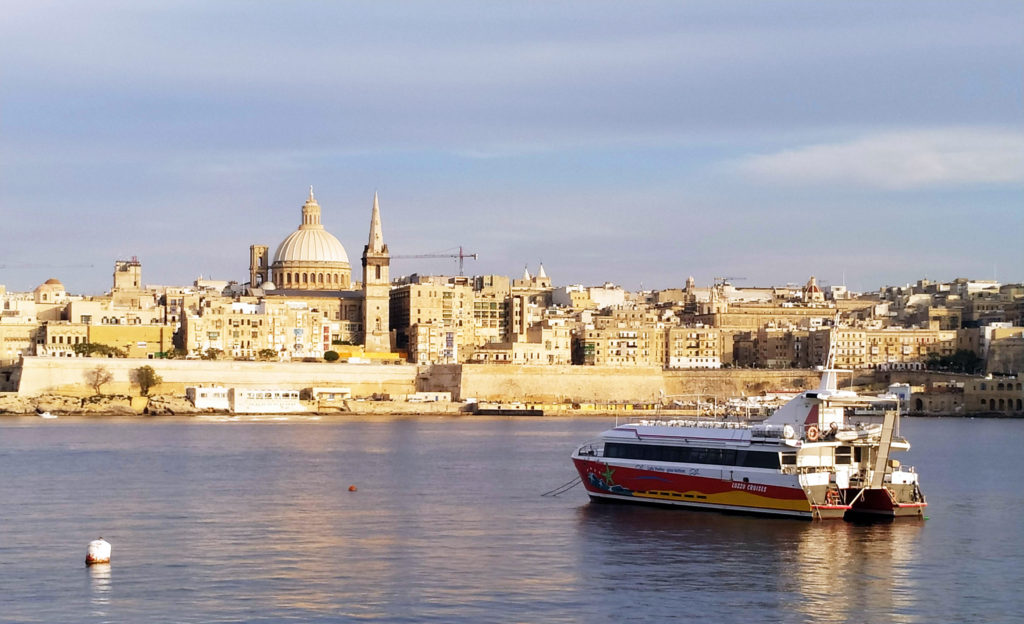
[362,193,391,352]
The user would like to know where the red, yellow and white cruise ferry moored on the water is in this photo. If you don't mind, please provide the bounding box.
[572,368,928,519]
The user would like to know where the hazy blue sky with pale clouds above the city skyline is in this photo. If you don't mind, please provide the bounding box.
[0,0,1024,294]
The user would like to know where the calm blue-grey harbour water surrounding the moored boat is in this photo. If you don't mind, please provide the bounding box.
[0,417,1024,623]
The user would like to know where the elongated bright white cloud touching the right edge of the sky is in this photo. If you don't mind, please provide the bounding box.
[733,127,1024,191]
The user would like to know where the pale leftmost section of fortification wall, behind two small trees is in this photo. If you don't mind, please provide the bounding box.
[17,357,417,397]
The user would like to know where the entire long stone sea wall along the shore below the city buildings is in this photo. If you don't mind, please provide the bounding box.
[18,357,819,403]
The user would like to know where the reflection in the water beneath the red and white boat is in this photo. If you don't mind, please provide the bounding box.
[578,503,923,622]
